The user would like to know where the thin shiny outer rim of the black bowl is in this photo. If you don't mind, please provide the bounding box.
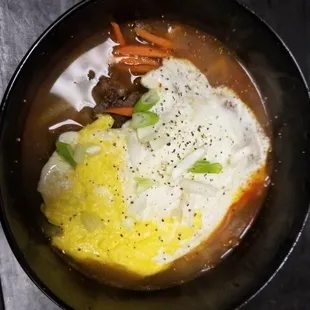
[0,0,310,310]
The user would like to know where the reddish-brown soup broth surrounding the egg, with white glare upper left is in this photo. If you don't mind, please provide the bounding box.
[22,20,269,289]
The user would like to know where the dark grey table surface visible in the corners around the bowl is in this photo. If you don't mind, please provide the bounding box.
[0,0,310,310]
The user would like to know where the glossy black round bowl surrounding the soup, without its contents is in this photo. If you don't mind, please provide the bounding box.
[0,0,310,310]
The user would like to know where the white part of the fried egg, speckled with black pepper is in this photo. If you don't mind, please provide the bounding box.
[120,58,270,263]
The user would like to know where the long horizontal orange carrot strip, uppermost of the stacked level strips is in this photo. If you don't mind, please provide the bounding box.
[114,45,170,58]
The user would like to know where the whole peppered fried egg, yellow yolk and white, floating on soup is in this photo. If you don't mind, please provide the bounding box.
[38,58,270,277]
